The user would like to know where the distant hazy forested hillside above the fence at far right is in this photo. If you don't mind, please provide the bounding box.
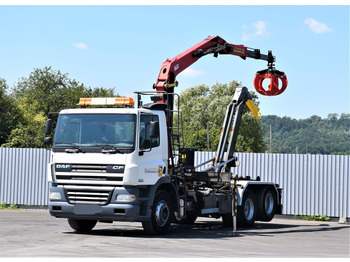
[261,113,350,154]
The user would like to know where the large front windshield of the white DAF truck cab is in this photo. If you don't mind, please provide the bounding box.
[53,114,136,149]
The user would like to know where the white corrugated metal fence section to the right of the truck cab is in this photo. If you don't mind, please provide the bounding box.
[195,152,350,217]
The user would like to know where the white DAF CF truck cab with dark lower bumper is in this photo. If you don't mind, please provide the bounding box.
[48,99,178,231]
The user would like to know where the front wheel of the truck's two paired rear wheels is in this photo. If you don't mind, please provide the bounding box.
[237,189,257,227]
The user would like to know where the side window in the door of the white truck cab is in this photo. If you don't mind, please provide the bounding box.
[140,115,159,150]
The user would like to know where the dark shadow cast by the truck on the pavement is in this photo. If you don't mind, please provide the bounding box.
[65,220,350,239]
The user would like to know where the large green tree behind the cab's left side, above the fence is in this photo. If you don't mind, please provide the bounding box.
[3,67,117,148]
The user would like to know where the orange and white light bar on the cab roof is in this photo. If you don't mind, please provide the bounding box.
[79,97,134,107]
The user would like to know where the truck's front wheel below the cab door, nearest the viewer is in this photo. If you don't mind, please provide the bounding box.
[142,191,174,235]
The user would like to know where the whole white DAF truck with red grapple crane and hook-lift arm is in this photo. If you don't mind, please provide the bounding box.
[44,36,287,234]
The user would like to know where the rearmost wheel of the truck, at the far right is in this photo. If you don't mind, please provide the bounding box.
[257,187,277,222]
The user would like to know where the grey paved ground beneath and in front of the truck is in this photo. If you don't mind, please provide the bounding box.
[0,210,350,259]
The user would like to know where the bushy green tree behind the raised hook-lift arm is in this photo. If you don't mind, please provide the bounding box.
[180,81,265,152]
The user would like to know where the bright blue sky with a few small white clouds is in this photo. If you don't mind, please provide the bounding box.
[0,1,350,119]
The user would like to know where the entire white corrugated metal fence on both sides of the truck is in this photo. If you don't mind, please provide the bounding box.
[0,148,350,217]
